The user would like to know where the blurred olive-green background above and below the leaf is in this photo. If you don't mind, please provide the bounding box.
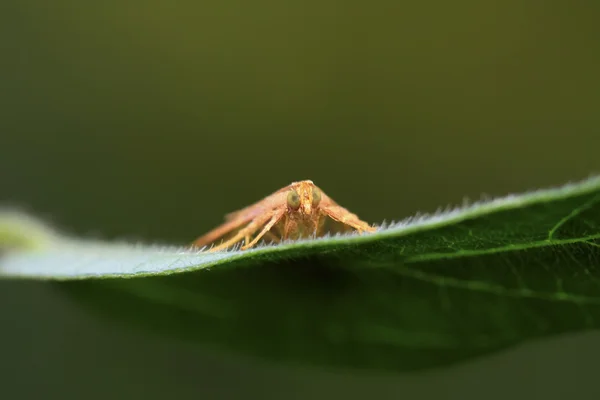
[0,0,600,399]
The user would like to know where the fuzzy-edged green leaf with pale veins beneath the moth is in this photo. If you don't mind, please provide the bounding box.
[0,177,600,371]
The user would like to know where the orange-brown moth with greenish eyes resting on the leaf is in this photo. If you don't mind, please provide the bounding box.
[191,180,376,252]
